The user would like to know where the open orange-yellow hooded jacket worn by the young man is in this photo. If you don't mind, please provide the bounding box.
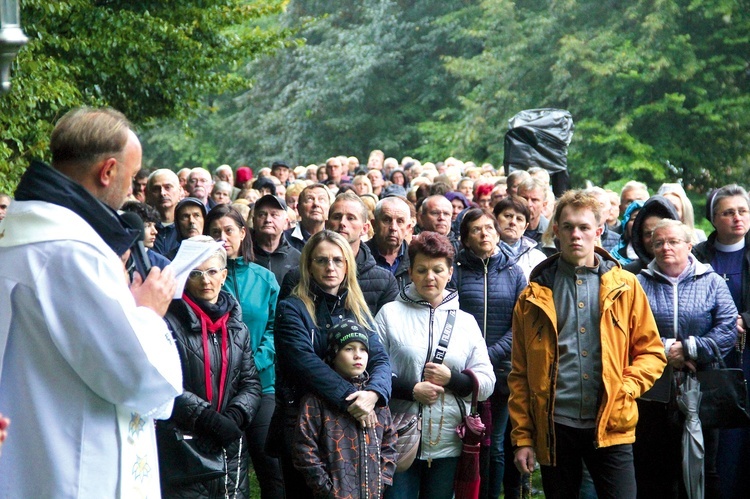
[508,248,666,466]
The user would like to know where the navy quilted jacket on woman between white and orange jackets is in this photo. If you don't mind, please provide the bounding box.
[450,249,527,369]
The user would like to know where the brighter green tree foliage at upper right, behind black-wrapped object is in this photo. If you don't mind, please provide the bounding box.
[420,0,750,191]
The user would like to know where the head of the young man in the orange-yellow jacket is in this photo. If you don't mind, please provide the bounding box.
[553,206,602,267]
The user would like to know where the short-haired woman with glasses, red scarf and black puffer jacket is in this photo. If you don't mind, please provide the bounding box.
[157,236,261,497]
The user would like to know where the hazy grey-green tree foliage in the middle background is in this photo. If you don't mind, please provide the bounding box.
[143,0,473,167]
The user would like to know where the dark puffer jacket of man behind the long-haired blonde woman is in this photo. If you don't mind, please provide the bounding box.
[279,244,398,317]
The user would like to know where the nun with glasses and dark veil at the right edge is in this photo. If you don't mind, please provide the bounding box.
[693,184,750,498]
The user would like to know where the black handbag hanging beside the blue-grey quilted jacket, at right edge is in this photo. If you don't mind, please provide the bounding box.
[695,338,750,429]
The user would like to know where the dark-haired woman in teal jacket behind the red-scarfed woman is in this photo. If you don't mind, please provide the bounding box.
[204,205,284,499]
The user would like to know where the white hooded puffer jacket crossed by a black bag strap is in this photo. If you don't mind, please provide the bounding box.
[375,284,495,459]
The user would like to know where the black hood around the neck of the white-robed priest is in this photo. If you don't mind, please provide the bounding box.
[15,161,143,256]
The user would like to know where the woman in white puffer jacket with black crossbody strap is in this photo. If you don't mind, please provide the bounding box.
[375,232,495,499]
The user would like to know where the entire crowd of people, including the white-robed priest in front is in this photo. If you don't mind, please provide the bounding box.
[0,108,750,499]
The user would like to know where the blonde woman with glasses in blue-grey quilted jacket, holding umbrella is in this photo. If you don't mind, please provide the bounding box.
[633,219,737,498]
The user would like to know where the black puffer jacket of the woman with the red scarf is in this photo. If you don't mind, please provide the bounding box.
[156,291,261,498]
